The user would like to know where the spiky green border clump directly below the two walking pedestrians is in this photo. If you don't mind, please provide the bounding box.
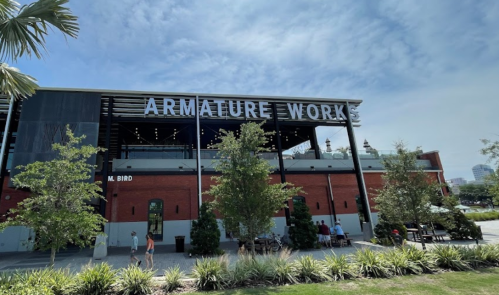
[118,265,154,295]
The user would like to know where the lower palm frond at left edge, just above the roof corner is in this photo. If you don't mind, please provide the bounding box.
[0,63,38,99]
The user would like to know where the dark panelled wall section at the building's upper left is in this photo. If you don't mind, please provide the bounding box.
[9,91,101,186]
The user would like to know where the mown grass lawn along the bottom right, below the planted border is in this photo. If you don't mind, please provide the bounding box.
[192,268,499,295]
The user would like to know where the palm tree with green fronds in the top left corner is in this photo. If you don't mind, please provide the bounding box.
[0,0,79,100]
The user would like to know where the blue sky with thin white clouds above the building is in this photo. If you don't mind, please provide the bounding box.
[10,0,499,180]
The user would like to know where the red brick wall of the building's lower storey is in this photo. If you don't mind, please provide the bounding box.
[0,172,446,222]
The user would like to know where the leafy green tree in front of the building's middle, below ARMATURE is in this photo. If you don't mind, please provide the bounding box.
[206,122,301,255]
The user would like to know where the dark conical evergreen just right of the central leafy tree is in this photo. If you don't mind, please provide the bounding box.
[289,202,318,249]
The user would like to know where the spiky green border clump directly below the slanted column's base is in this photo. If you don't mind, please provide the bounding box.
[354,249,391,278]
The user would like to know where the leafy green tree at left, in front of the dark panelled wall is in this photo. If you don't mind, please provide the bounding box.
[0,126,106,265]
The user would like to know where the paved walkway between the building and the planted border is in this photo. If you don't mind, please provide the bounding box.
[0,220,499,276]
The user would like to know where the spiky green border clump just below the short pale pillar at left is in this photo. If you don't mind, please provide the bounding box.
[71,262,117,295]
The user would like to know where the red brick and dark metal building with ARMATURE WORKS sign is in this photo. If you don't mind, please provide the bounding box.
[0,88,446,252]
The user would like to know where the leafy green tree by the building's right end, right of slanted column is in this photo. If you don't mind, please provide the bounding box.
[375,142,442,249]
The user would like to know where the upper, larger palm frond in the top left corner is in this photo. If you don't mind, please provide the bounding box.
[0,0,79,60]
